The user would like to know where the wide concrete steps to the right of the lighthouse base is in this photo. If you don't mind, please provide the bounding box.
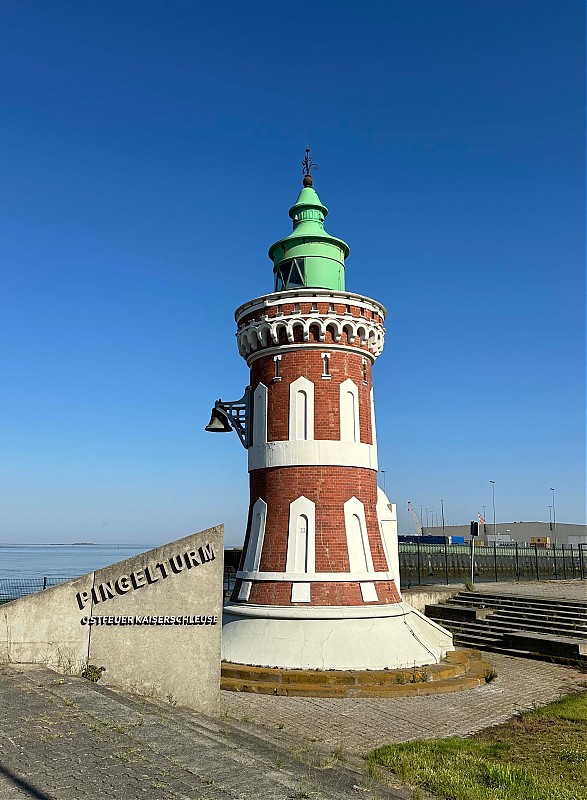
[425,592,587,666]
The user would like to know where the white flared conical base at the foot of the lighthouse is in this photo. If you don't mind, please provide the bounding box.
[222,603,454,670]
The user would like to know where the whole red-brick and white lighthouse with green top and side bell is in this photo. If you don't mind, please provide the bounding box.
[208,150,453,670]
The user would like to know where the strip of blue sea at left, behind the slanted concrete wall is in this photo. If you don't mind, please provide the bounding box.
[0,543,157,583]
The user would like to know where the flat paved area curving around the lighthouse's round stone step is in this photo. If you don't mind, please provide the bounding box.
[222,653,587,753]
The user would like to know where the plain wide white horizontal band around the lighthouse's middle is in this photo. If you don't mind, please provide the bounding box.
[248,439,378,472]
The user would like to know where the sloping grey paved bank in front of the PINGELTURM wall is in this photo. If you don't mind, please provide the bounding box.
[0,665,410,800]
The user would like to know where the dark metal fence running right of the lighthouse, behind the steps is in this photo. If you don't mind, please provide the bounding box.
[399,542,587,588]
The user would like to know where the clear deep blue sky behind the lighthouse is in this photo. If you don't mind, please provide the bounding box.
[0,0,585,544]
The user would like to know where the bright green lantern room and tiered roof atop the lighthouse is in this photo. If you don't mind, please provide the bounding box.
[269,176,349,292]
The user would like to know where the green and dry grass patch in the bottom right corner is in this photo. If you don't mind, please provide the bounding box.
[367,692,587,800]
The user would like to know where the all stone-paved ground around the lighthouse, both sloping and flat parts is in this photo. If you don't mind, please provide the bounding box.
[0,581,587,800]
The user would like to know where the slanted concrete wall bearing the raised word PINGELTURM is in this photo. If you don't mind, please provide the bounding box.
[0,525,224,710]
